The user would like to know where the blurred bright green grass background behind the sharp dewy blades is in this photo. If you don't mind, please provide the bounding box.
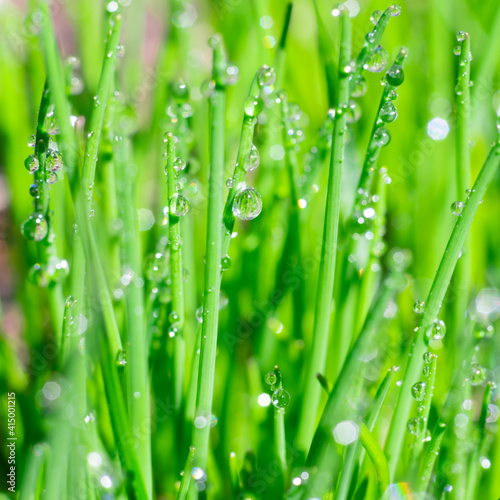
[0,0,500,499]
